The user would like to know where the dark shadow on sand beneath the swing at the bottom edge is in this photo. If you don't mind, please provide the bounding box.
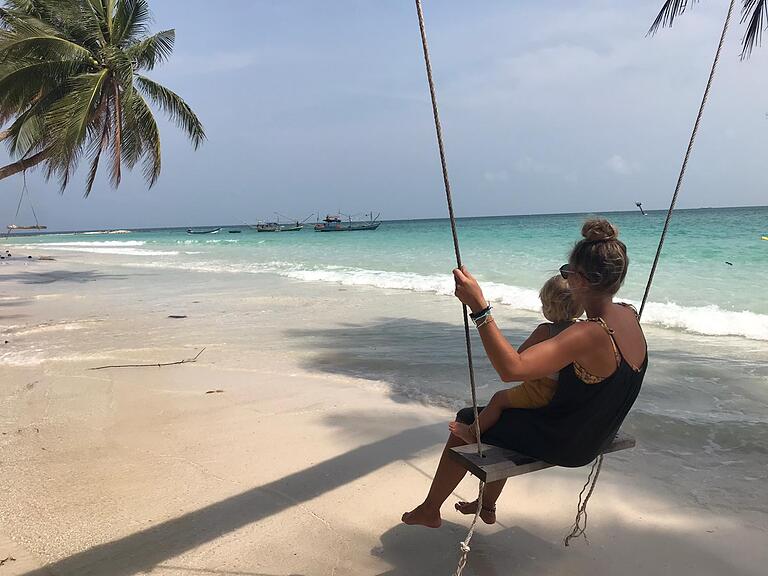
[371,521,751,576]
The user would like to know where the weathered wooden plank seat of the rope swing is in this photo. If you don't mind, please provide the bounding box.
[448,431,635,482]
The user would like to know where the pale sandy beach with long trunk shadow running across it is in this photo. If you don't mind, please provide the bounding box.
[0,253,768,576]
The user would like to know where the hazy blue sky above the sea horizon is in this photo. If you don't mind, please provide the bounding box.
[0,0,768,229]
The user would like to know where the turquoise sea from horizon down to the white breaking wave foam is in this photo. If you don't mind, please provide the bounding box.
[3,207,768,340]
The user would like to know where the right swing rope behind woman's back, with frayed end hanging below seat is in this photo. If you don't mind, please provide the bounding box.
[563,0,736,546]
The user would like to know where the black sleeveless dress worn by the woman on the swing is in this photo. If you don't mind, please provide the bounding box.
[456,319,648,467]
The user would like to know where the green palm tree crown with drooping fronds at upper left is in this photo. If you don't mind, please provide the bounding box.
[0,0,205,196]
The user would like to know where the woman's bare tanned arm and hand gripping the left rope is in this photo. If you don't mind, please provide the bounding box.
[454,267,594,382]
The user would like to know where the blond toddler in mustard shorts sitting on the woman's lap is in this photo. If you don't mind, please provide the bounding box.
[448,274,584,443]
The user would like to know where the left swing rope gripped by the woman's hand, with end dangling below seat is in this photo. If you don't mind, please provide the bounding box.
[416,0,485,576]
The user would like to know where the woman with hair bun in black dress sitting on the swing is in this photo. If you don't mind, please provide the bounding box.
[402,219,648,528]
